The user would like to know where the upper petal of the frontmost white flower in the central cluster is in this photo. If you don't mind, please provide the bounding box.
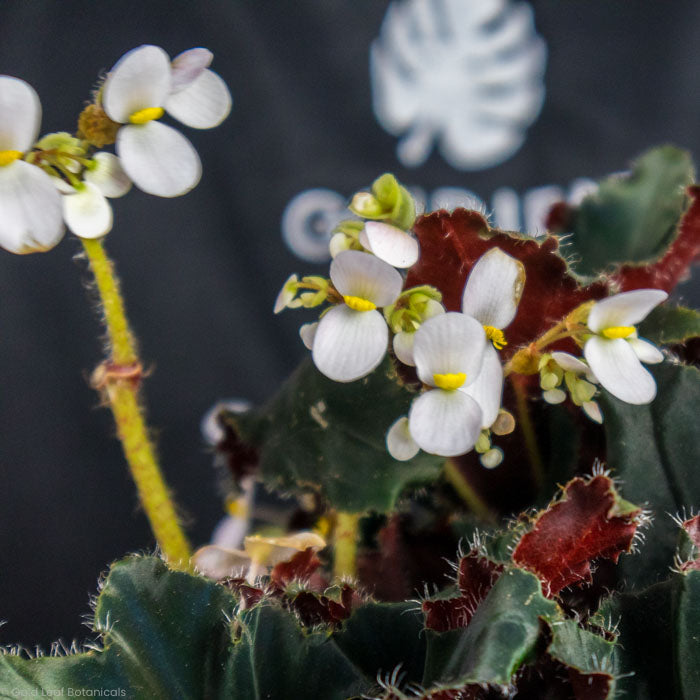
[413,311,486,386]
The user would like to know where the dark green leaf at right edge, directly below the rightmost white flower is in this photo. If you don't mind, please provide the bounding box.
[600,363,700,589]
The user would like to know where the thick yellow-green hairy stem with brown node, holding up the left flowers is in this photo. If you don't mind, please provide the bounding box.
[81,239,191,569]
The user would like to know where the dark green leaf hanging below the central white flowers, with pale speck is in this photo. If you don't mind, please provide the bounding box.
[225,359,444,513]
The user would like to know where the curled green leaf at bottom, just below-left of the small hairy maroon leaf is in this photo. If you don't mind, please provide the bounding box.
[423,569,558,687]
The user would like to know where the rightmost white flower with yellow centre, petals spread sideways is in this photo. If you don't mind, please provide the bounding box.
[583,289,668,404]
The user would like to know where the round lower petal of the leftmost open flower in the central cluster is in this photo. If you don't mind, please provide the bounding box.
[313,304,389,382]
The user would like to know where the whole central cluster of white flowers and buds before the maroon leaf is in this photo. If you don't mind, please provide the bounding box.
[275,175,667,468]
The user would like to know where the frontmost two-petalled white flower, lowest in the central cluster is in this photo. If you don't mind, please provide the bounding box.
[408,312,486,457]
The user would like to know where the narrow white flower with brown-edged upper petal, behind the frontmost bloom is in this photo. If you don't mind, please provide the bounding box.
[462,248,525,428]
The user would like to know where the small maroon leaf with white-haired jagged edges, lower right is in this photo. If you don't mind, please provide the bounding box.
[513,475,641,597]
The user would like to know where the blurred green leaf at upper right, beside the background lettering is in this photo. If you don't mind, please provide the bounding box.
[569,146,694,275]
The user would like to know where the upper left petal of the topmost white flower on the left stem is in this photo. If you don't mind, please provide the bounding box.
[102,45,170,124]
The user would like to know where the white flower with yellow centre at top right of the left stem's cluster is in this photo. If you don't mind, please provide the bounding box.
[102,45,231,197]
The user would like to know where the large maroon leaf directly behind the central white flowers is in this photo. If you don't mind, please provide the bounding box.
[407,209,608,359]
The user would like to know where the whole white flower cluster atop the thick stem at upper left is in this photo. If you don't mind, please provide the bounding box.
[0,46,231,253]
